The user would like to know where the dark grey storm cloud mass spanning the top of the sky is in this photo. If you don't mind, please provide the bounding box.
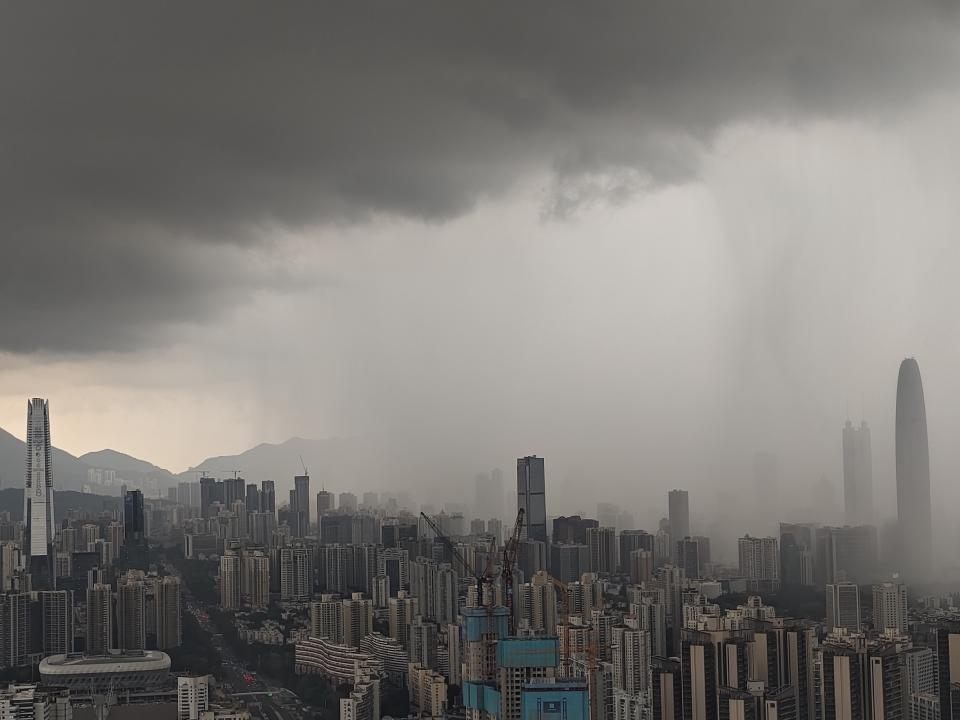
[0,0,958,351]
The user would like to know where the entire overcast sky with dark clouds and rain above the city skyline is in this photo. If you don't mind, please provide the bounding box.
[0,0,960,544]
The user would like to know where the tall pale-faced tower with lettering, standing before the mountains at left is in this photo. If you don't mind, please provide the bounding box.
[23,398,55,587]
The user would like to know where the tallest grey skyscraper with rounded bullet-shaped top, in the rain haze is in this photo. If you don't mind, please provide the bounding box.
[896,358,933,579]
